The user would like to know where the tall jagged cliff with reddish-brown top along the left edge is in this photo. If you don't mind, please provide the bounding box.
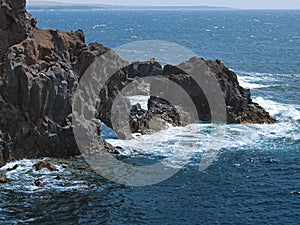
[0,0,113,166]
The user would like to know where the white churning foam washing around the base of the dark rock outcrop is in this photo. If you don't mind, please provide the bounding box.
[107,90,300,166]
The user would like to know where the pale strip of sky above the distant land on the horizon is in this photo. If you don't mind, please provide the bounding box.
[27,0,300,9]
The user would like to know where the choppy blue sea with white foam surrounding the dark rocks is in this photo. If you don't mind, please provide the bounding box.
[0,9,300,225]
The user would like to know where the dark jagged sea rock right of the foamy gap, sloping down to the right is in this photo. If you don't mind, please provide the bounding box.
[125,57,276,134]
